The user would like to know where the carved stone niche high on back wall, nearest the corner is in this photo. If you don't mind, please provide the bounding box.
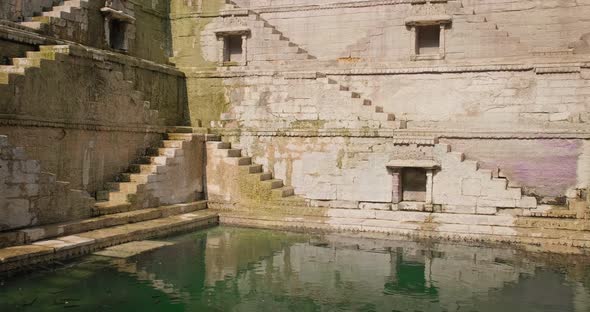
[215,26,250,66]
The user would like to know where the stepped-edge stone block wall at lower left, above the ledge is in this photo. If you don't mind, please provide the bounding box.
[0,132,94,231]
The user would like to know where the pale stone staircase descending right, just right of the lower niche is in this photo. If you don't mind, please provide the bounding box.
[434,143,537,214]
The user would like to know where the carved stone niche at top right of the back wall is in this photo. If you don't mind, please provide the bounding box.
[405,2,452,61]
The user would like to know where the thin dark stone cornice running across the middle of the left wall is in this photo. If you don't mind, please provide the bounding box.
[0,114,168,134]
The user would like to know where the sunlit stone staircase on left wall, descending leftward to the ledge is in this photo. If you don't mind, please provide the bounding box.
[94,133,200,215]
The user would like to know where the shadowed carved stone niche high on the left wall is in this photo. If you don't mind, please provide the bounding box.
[100,0,135,52]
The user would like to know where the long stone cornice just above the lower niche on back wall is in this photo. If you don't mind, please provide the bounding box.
[210,128,590,142]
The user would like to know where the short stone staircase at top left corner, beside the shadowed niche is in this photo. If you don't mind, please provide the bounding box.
[20,0,89,29]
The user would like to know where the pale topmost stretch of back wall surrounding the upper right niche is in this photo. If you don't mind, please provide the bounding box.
[229,0,590,61]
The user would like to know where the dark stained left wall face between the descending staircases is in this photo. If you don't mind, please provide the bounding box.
[0,43,185,193]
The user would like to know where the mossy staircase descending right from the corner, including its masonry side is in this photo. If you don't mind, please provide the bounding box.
[206,136,295,201]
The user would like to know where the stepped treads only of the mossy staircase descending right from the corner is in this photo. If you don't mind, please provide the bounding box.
[206,136,295,199]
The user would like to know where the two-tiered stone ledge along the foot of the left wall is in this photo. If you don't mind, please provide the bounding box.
[0,202,219,273]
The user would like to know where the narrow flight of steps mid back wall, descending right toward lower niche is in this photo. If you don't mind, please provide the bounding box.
[316,74,399,128]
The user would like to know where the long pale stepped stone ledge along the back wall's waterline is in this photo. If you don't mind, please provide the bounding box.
[216,207,590,254]
